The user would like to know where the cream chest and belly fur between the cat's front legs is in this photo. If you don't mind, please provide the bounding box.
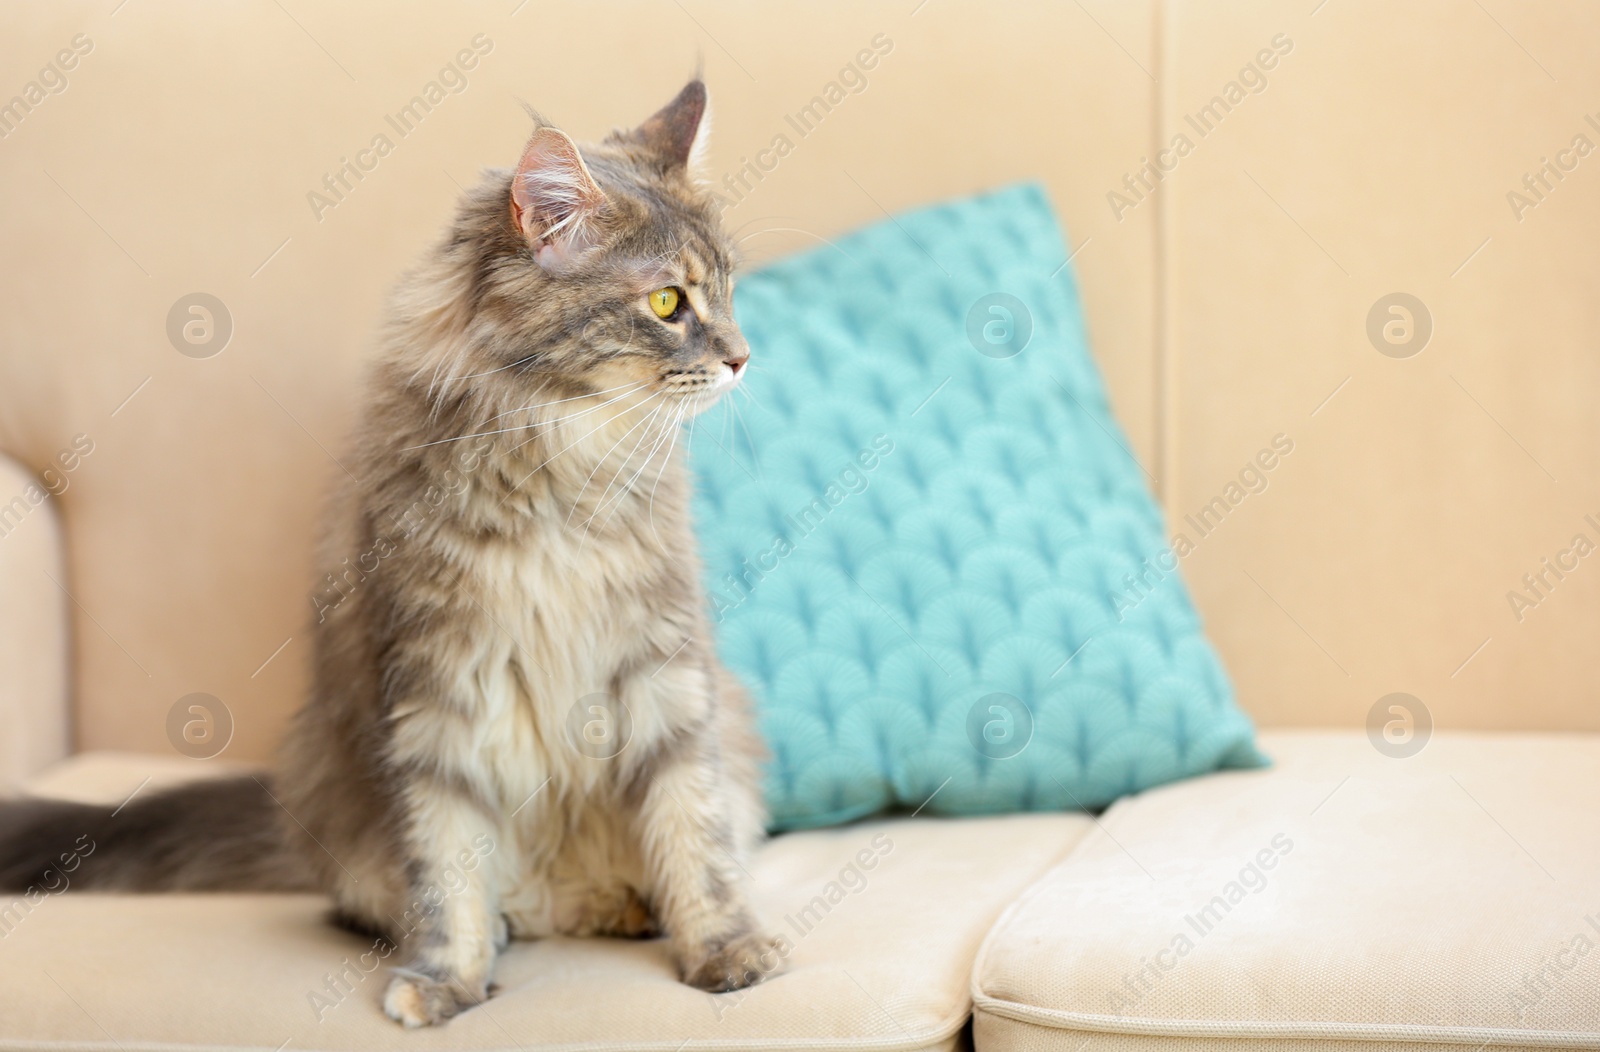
[458,492,699,937]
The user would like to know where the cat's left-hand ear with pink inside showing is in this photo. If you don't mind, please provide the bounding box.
[510,128,606,270]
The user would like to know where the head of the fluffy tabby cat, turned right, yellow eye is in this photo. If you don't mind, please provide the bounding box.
[457,80,749,414]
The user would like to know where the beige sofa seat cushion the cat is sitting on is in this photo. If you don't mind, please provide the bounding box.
[0,756,1093,1052]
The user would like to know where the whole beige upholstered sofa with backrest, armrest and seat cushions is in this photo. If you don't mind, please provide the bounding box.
[0,0,1600,1052]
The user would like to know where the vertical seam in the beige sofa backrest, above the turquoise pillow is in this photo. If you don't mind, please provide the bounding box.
[1150,0,1178,523]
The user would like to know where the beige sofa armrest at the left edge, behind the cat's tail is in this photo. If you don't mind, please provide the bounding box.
[0,456,72,793]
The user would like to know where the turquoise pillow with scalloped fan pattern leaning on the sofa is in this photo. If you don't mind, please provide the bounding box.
[691,185,1264,830]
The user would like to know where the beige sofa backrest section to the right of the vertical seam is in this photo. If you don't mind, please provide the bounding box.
[1163,0,1600,729]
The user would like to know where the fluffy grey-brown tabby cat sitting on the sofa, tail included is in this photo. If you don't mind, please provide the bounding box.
[0,80,778,1026]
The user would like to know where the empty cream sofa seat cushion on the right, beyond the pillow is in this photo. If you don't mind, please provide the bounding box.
[973,732,1600,1052]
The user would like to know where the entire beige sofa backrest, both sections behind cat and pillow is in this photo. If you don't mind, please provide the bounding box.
[0,0,1600,758]
